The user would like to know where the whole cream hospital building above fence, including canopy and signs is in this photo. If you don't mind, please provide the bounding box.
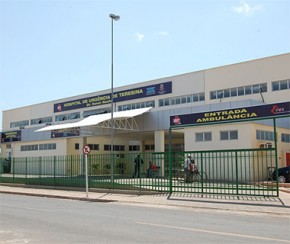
[1,53,290,167]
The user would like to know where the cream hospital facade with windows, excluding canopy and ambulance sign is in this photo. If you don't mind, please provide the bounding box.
[1,53,290,166]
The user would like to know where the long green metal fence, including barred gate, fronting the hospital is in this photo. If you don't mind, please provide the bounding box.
[0,148,278,196]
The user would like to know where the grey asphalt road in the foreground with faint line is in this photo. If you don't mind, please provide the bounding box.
[0,194,290,244]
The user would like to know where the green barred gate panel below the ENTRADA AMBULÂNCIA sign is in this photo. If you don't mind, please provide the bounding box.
[170,148,279,196]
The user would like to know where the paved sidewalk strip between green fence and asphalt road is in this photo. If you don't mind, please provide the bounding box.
[0,184,290,218]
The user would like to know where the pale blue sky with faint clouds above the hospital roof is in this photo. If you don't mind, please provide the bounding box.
[0,0,290,130]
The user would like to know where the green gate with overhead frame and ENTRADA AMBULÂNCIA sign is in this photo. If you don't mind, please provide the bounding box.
[169,102,290,196]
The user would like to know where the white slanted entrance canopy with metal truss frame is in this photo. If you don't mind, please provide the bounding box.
[35,107,152,132]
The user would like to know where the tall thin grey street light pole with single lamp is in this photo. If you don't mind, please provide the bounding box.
[109,14,120,181]
